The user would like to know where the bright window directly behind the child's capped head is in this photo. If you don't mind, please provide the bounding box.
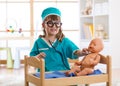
[34,0,79,37]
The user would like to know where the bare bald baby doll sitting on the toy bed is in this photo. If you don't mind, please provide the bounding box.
[65,38,104,76]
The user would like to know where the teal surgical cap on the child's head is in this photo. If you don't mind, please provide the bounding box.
[41,7,61,21]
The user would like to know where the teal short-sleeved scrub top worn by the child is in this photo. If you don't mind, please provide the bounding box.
[30,37,79,71]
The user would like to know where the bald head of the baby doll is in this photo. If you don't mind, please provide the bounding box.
[88,38,104,53]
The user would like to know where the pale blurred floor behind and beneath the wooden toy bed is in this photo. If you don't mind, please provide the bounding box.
[0,65,120,86]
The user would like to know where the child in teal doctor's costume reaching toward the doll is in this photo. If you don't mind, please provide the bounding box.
[30,7,87,71]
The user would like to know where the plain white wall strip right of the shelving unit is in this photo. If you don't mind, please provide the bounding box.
[110,0,120,68]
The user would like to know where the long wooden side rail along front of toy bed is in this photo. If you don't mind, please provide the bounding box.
[45,74,108,86]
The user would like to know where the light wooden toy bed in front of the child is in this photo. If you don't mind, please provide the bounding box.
[25,55,112,86]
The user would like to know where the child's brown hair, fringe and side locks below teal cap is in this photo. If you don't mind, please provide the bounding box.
[39,15,65,42]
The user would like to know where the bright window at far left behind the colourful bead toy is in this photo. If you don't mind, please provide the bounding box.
[0,0,30,36]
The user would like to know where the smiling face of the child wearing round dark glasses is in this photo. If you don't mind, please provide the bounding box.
[44,17,62,35]
